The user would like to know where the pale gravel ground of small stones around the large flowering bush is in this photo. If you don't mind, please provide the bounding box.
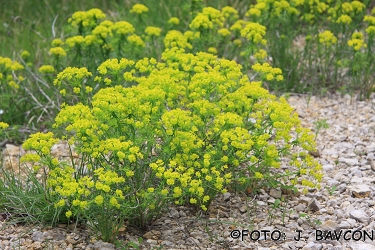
[0,95,375,250]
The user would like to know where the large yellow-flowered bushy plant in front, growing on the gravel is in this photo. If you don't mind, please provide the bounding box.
[23,47,322,240]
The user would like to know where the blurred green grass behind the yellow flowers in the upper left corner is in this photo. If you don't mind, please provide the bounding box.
[0,0,118,60]
